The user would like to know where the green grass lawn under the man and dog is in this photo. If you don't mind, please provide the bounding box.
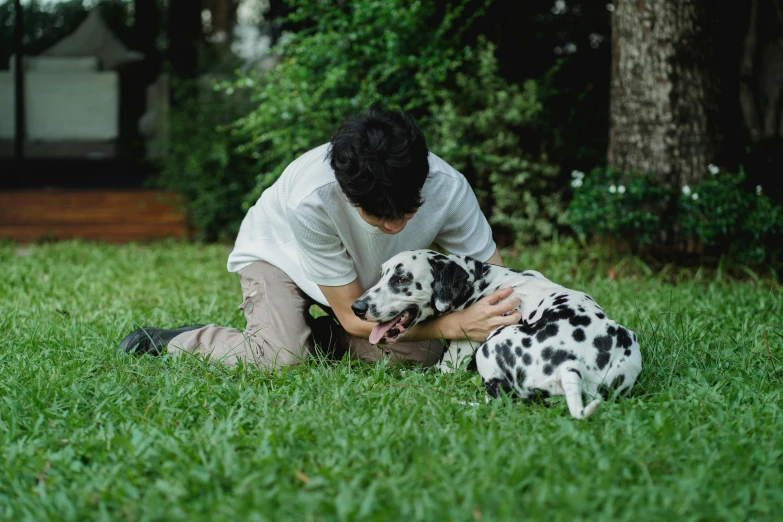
[0,242,783,521]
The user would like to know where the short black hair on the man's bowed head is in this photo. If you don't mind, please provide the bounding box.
[328,102,430,220]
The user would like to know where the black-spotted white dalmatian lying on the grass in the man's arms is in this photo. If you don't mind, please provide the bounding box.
[352,250,642,419]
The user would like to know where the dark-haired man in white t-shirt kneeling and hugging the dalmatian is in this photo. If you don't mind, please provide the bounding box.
[119,103,520,368]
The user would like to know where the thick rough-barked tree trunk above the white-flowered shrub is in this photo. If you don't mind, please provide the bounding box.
[608,0,720,185]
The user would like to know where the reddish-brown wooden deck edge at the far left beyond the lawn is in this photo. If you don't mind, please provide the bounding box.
[0,190,189,243]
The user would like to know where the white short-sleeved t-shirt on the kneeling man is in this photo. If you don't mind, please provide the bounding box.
[228,143,495,306]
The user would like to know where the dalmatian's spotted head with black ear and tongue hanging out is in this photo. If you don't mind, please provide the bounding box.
[351,250,480,344]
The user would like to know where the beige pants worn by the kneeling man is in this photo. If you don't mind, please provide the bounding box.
[168,261,443,368]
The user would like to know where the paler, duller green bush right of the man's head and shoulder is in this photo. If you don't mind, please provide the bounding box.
[429,39,566,244]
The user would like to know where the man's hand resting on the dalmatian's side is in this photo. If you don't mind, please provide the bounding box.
[447,287,522,343]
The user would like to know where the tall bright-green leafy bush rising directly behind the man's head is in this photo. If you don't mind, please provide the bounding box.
[225,0,478,209]
